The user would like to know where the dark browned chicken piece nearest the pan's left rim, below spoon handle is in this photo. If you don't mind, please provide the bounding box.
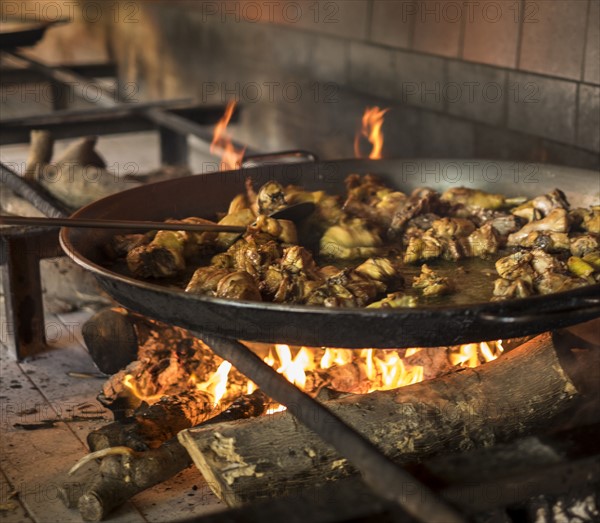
[127,231,188,278]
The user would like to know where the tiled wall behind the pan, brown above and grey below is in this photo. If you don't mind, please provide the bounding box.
[7,0,600,168]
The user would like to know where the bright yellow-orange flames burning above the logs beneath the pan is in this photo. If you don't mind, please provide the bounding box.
[123,340,504,413]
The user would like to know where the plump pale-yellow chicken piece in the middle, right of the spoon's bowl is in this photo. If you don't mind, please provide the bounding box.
[319,218,383,260]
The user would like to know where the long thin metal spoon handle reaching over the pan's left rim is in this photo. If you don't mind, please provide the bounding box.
[0,215,248,233]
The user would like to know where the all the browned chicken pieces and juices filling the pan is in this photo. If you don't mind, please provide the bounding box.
[111,175,600,308]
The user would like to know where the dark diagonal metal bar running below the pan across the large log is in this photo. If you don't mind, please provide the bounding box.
[196,333,467,523]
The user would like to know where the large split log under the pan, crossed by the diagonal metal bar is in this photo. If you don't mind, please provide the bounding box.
[178,334,598,506]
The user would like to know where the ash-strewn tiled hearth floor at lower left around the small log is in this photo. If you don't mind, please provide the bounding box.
[0,312,225,523]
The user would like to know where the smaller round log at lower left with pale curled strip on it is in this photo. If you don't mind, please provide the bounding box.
[71,390,269,521]
